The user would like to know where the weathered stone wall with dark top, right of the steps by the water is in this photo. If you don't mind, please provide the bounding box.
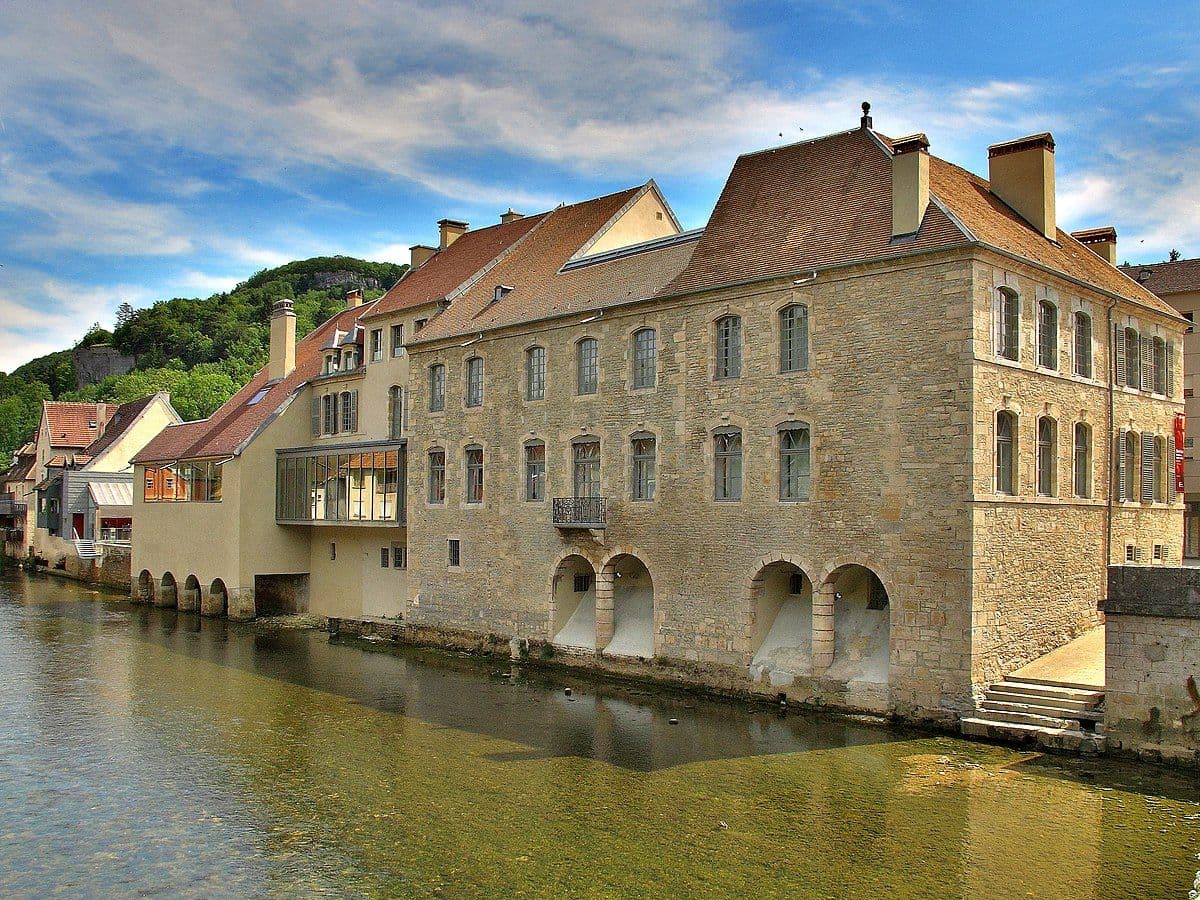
[1104,568,1200,764]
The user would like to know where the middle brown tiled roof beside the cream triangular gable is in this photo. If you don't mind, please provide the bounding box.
[414,186,696,343]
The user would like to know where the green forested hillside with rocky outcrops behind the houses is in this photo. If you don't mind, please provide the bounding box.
[0,257,408,470]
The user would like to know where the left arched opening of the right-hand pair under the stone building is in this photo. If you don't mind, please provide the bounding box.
[750,562,812,686]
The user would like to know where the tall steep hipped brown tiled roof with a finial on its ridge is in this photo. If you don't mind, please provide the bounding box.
[662,128,1172,313]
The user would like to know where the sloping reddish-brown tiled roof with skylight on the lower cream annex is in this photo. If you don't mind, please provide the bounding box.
[133,304,372,462]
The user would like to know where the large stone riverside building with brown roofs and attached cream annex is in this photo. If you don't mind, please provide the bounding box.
[134,115,1186,720]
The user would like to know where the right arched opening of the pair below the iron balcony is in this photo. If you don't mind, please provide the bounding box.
[596,547,655,659]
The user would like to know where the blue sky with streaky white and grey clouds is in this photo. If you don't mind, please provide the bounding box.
[0,0,1200,371]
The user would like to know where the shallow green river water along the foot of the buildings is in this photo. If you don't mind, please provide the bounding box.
[0,570,1200,899]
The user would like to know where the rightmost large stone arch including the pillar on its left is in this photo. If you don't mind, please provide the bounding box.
[812,560,893,684]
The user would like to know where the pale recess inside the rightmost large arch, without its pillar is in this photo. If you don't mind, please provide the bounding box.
[826,565,892,684]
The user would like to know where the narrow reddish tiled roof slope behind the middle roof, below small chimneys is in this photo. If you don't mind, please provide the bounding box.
[355,212,546,318]
